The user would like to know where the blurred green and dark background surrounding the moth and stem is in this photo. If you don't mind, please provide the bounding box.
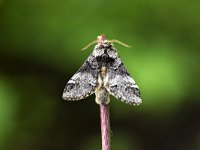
[0,0,200,150]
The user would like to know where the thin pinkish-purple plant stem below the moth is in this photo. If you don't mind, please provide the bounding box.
[100,104,111,150]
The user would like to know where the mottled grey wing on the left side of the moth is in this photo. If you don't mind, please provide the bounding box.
[62,55,98,100]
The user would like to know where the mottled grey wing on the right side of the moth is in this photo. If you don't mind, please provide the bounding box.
[106,58,142,105]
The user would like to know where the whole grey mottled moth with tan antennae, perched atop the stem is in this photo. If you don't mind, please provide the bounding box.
[62,34,142,105]
